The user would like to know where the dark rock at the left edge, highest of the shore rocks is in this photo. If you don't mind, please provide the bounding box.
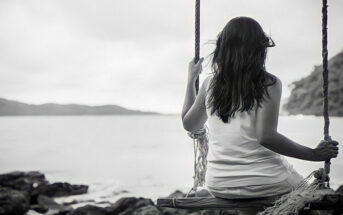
[0,171,47,192]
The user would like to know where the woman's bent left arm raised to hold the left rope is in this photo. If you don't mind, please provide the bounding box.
[182,58,208,132]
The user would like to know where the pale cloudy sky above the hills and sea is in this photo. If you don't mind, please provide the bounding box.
[0,0,343,113]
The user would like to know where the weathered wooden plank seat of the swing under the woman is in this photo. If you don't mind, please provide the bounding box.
[157,193,343,211]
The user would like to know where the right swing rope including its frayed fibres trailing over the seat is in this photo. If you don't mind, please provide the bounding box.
[260,0,335,215]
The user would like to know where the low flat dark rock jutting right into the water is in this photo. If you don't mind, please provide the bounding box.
[31,182,88,197]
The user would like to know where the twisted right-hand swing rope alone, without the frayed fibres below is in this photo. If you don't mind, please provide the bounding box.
[322,0,331,187]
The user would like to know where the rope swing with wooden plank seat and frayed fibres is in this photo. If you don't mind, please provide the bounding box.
[157,0,343,214]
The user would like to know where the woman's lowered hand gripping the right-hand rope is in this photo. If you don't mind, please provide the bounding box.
[313,140,338,161]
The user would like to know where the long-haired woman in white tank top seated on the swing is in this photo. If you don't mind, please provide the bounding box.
[182,17,338,202]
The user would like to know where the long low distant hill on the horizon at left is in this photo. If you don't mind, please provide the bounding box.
[0,98,158,116]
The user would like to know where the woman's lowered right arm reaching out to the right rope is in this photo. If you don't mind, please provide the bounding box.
[256,79,338,161]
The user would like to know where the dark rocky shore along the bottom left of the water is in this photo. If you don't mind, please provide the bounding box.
[0,171,217,215]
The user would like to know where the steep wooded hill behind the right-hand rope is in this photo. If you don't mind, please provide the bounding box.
[283,51,343,116]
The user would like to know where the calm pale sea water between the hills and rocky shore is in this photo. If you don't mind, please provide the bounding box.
[0,116,343,205]
